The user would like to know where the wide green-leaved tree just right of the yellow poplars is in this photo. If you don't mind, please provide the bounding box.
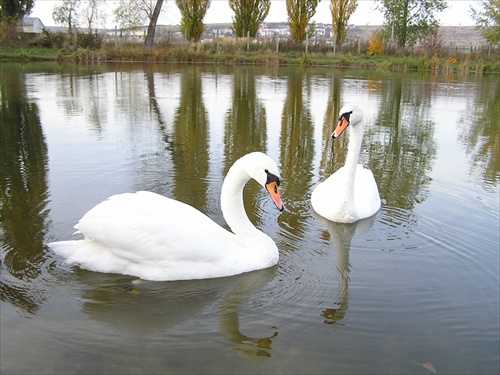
[377,0,447,48]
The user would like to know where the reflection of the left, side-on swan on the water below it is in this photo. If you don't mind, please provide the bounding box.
[77,267,278,360]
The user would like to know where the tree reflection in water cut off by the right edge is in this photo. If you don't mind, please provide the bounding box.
[459,77,500,186]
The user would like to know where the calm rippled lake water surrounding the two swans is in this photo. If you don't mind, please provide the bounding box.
[0,63,500,374]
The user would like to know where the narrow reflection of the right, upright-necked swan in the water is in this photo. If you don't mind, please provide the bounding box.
[313,211,377,324]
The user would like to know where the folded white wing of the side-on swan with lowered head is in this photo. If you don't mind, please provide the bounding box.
[75,192,234,263]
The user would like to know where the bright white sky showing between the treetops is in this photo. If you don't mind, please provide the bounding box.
[29,0,479,28]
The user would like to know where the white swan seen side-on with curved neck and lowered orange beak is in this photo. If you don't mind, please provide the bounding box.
[48,152,283,280]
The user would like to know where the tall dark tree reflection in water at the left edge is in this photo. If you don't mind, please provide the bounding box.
[0,64,48,313]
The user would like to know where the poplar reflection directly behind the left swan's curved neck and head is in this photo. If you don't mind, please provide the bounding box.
[223,67,267,227]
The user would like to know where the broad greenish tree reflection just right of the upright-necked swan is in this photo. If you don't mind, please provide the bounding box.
[370,75,437,209]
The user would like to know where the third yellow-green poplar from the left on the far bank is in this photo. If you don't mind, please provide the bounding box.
[286,0,319,43]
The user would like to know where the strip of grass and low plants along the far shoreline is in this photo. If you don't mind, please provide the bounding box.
[0,39,500,75]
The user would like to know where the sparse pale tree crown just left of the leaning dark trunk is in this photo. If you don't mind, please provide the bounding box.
[114,0,156,29]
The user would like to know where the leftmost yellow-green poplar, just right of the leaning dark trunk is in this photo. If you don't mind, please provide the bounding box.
[175,0,211,42]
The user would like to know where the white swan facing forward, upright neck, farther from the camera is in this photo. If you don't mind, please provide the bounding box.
[311,105,380,223]
